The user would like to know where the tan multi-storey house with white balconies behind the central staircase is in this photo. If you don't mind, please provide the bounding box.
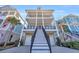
[23,7,59,45]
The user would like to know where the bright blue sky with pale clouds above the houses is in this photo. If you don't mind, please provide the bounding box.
[12,5,79,20]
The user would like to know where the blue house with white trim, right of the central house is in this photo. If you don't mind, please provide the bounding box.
[58,14,79,40]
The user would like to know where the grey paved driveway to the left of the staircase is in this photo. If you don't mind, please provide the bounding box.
[0,46,30,53]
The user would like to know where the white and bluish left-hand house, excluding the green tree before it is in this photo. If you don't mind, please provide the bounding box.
[0,5,23,45]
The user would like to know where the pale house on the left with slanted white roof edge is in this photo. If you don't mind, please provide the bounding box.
[0,5,23,46]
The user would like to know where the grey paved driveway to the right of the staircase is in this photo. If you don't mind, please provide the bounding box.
[52,46,79,53]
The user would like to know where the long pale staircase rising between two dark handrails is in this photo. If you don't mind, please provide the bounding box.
[32,28,50,53]
